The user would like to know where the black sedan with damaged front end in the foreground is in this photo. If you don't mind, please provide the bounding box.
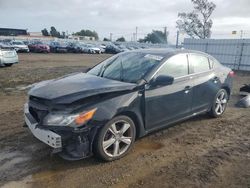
[24,49,234,161]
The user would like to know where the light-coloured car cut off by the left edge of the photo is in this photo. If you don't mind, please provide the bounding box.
[0,43,19,67]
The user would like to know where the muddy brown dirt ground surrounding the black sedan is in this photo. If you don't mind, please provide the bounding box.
[0,54,250,188]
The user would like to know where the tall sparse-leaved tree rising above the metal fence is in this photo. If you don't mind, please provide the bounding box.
[176,0,216,39]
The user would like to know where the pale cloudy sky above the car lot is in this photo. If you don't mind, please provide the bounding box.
[0,0,250,43]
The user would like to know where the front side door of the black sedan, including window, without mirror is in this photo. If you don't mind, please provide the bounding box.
[145,54,193,130]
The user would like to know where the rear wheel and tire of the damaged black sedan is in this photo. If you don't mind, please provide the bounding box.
[209,89,229,118]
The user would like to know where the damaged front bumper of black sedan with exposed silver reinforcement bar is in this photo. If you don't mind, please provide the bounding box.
[24,103,97,160]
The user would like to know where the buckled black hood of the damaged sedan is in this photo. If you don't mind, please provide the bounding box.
[29,73,136,103]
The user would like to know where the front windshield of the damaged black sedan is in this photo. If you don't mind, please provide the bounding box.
[88,52,163,83]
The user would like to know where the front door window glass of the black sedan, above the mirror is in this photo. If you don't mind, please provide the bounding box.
[157,54,188,78]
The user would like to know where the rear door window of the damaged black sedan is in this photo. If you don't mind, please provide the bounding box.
[188,54,210,73]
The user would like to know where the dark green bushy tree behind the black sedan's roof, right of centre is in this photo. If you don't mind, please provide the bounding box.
[139,30,168,43]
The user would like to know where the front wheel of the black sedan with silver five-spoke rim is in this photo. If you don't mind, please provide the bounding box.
[93,115,136,161]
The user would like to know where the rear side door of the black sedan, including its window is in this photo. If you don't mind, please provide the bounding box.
[188,53,220,113]
